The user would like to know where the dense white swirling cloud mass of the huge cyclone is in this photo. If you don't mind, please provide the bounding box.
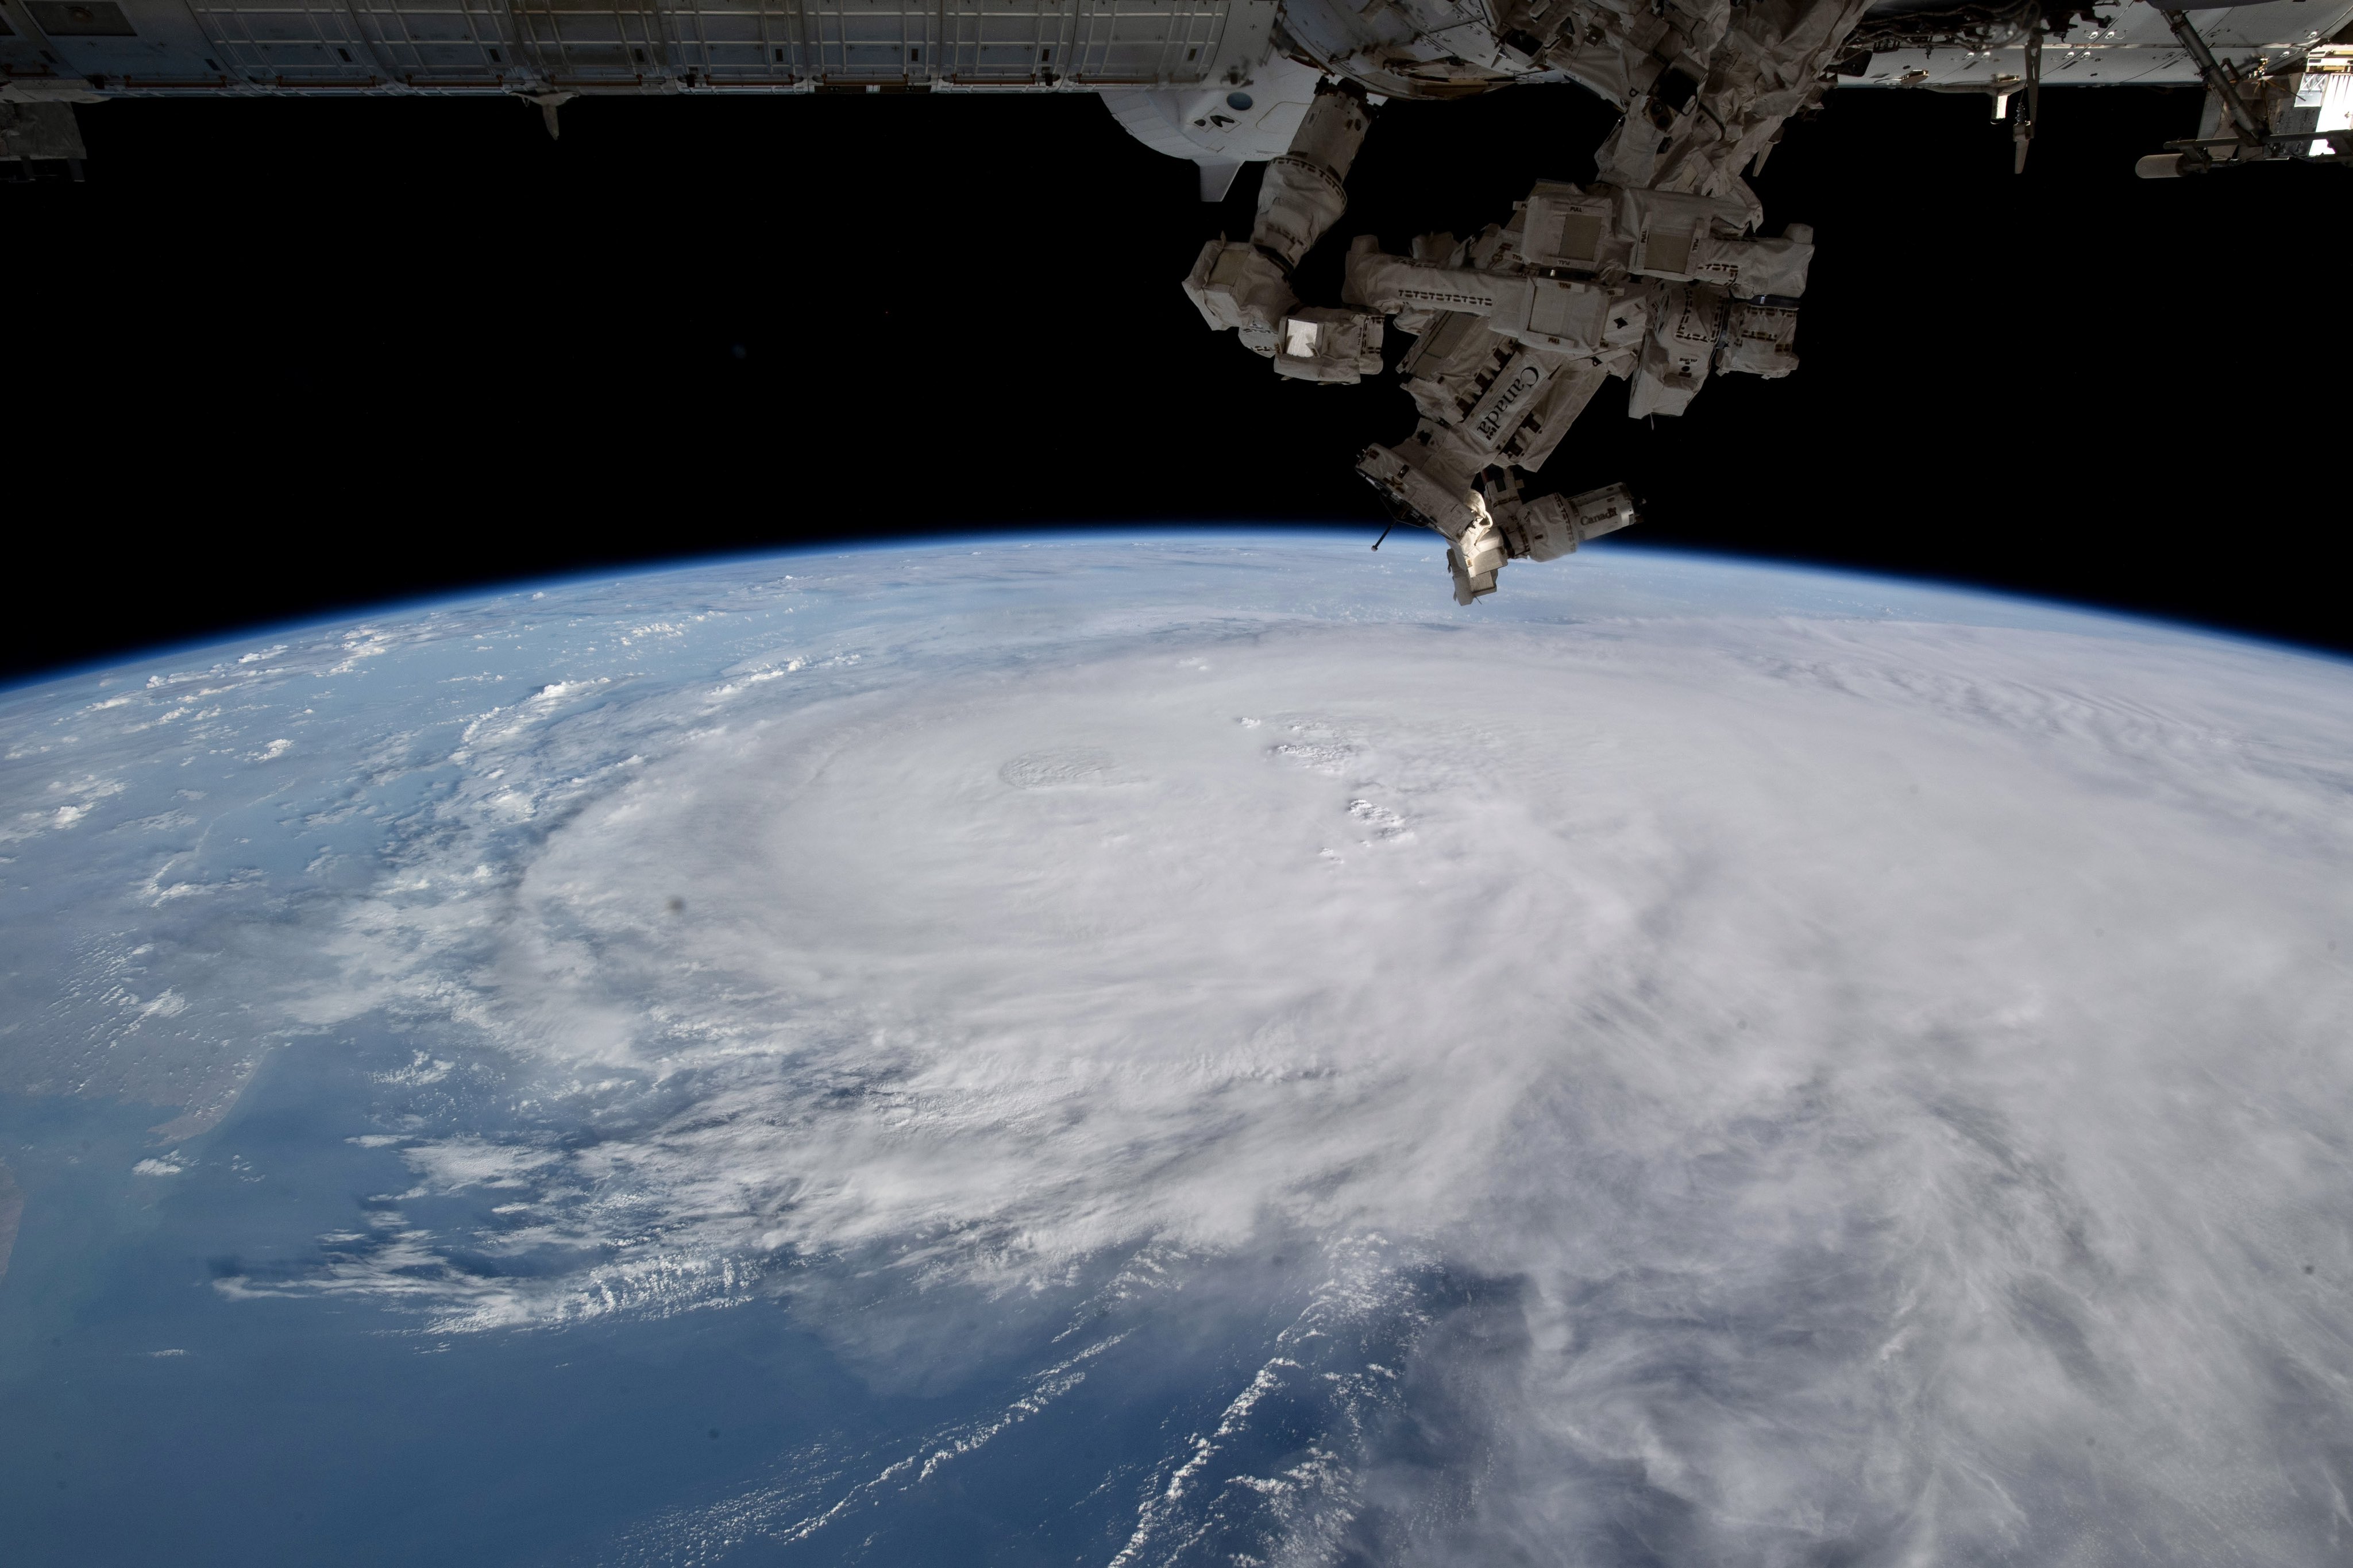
[289,594,2353,1561]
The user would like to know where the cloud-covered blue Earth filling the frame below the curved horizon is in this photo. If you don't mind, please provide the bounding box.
[0,529,2353,1568]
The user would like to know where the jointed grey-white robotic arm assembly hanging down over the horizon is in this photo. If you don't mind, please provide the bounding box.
[1183,0,1866,604]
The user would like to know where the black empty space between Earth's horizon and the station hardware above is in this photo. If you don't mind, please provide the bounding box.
[0,87,2353,675]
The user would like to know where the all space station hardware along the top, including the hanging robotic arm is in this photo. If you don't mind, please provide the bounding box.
[0,0,2353,604]
